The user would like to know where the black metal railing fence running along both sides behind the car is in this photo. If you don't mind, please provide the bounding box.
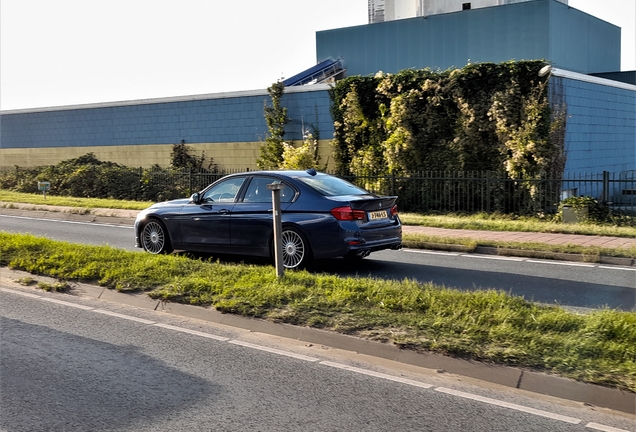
[0,166,636,215]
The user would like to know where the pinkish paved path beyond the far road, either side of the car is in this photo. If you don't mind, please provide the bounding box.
[0,202,636,248]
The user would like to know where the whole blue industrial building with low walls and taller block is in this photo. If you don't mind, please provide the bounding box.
[0,0,636,175]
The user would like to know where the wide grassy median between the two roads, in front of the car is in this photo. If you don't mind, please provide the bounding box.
[0,232,636,392]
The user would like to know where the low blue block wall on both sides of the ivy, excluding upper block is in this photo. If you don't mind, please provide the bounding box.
[0,74,636,172]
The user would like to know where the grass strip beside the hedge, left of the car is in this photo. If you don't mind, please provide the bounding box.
[0,189,152,210]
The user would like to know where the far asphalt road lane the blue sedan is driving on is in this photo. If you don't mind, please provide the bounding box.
[0,215,636,310]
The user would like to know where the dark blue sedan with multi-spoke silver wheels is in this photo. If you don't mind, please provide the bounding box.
[135,169,402,268]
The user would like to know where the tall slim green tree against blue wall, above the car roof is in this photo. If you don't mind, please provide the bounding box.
[256,81,289,169]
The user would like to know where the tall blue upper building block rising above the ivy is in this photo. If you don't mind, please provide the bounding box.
[316,0,620,76]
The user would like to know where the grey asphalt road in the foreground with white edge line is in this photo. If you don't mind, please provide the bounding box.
[0,286,633,432]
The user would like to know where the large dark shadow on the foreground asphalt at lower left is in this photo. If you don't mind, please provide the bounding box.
[0,317,223,432]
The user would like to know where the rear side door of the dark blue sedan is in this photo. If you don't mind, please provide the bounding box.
[230,176,296,250]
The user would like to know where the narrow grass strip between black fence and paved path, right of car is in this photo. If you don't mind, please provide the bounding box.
[400,213,636,237]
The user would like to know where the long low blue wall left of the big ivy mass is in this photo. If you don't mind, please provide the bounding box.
[0,86,333,148]
